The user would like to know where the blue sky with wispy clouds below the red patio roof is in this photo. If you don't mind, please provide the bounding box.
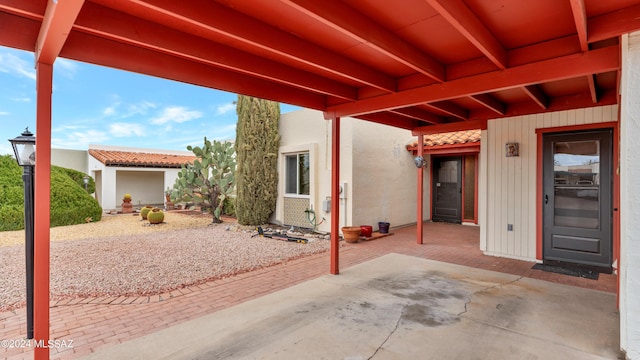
[0,46,298,154]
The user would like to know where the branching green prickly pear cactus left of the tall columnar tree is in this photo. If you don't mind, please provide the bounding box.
[171,137,236,223]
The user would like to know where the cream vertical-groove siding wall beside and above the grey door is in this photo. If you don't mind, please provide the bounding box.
[478,106,618,260]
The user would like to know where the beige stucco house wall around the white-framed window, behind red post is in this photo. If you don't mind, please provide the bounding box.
[272,109,417,232]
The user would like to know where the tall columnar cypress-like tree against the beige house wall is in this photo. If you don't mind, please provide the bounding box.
[235,95,280,225]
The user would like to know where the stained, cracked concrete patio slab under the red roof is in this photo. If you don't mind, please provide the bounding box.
[86,254,619,359]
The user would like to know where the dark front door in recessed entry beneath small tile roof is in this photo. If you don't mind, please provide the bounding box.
[431,156,462,223]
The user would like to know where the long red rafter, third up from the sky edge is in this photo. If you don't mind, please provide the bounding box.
[94,0,397,92]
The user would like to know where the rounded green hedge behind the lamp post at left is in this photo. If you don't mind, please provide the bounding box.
[0,155,102,231]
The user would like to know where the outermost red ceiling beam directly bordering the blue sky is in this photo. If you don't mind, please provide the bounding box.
[60,32,326,110]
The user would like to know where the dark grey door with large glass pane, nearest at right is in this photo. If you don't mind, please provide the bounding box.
[542,130,613,272]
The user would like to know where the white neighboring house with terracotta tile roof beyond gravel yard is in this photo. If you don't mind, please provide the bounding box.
[51,145,195,211]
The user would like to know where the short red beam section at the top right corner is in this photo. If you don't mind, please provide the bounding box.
[587,4,640,43]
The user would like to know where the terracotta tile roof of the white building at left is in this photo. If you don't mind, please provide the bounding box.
[89,149,196,168]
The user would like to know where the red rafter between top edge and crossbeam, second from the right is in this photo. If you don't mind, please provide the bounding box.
[426,0,507,69]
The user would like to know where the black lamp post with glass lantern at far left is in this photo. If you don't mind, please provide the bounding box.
[9,128,36,339]
